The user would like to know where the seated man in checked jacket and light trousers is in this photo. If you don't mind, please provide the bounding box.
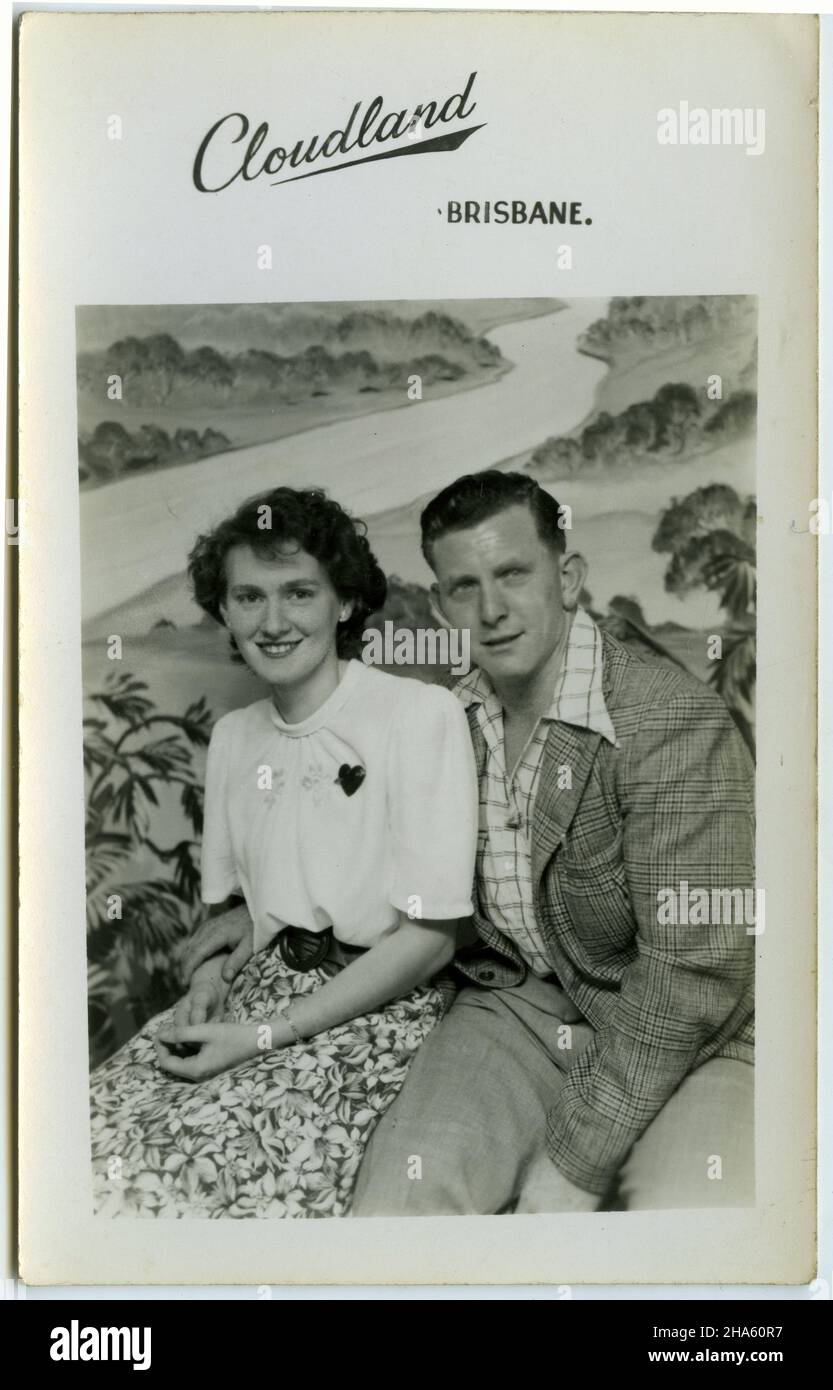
[353,470,754,1215]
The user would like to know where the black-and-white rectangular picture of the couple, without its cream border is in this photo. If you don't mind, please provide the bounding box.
[75,295,765,1219]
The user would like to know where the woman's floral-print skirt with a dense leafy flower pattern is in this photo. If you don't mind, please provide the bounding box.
[90,945,442,1216]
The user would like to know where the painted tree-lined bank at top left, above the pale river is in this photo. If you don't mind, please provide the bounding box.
[76,300,547,489]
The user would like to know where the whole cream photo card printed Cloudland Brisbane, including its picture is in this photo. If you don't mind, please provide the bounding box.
[17,11,819,1286]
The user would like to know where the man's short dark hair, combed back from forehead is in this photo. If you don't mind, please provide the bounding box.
[420,468,566,569]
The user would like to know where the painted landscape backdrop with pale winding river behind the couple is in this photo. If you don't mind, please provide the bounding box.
[76,296,757,1065]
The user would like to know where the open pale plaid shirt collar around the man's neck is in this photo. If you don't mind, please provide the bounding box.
[453,609,619,748]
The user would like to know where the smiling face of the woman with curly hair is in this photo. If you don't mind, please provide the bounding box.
[220,542,350,698]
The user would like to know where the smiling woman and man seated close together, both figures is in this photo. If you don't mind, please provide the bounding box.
[90,470,754,1216]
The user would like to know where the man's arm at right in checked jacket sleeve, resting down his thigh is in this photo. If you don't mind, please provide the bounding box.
[547,691,754,1194]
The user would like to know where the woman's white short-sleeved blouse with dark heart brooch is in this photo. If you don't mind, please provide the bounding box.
[202,660,477,951]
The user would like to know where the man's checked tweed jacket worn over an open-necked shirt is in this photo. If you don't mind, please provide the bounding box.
[453,632,755,1194]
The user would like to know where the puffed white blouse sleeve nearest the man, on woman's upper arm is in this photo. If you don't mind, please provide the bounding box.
[388,678,477,922]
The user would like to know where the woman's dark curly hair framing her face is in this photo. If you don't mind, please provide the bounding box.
[188,488,388,662]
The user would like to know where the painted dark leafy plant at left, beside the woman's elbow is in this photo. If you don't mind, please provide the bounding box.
[83,673,213,1065]
